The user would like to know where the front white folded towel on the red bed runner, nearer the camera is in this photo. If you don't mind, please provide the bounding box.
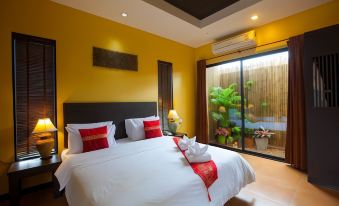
[185,142,212,163]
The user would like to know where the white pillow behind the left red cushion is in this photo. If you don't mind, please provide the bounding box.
[66,121,116,154]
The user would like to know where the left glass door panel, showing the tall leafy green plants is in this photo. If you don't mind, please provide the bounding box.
[206,61,242,149]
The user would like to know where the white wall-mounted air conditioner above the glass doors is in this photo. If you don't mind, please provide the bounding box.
[212,30,256,55]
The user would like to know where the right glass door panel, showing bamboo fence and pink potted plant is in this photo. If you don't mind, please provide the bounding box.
[243,51,288,158]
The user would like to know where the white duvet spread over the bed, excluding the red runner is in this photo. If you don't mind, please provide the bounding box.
[55,137,255,206]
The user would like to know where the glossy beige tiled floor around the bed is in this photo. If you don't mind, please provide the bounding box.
[0,155,339,206]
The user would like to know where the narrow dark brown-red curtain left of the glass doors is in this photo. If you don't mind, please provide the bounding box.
[195,60,208,144]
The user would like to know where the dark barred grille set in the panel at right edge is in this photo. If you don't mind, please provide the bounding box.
[313,53,339,107]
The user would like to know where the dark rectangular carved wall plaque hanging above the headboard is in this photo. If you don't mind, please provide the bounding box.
[93,47,138,71]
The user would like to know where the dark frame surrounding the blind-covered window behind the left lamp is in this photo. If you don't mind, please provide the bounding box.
[11,32,58,162]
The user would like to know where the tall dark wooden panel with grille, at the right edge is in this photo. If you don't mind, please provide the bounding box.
[304,25,339,190]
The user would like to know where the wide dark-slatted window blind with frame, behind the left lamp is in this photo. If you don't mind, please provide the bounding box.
[12,33,57,160]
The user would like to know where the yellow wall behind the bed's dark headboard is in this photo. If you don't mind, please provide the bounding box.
[0,0,195,194]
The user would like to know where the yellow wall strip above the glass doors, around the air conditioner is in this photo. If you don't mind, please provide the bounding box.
[195,0,339,64]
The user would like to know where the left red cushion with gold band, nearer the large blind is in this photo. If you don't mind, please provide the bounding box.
[79,126,108,152]
